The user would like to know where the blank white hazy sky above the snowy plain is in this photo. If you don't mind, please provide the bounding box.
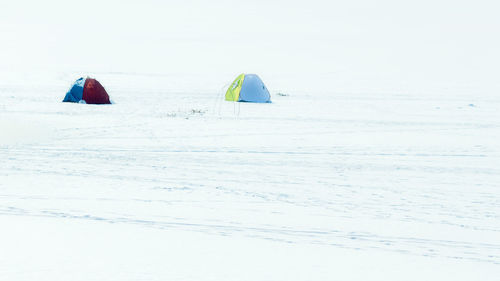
[0,0,500,93]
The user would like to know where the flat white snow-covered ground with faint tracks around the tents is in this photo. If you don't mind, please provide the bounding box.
[0,69,500,280]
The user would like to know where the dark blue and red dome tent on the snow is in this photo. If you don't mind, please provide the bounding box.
[63,77,111,104]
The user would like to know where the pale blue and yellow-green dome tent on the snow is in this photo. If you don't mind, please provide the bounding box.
[226,74,271,103]
